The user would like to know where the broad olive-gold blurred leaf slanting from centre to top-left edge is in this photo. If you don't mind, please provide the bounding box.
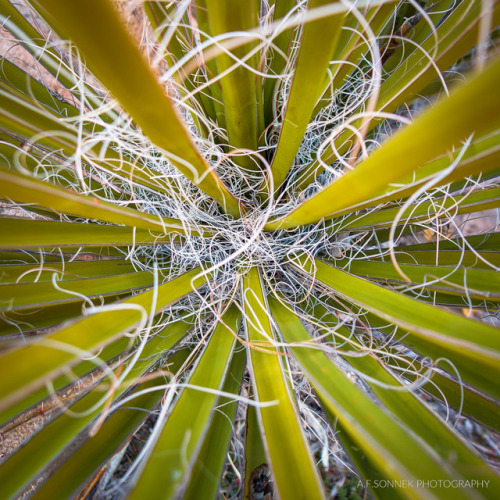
[33,0,239,217]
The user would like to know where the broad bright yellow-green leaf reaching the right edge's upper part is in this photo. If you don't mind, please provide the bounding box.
[266,52,500,230]
